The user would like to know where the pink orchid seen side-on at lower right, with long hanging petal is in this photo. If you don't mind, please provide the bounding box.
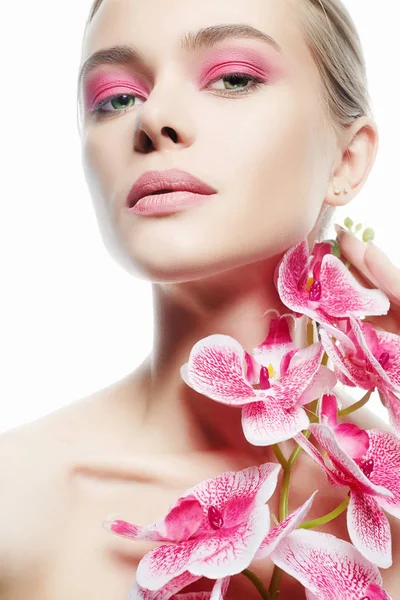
[295,394,400,568]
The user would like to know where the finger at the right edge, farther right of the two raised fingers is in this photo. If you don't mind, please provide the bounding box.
[365,242,400,306]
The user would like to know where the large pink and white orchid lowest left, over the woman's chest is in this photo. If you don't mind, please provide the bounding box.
[103,463,316,600]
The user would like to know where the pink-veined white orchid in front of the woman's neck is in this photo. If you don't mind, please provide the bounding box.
[181,316,337,446]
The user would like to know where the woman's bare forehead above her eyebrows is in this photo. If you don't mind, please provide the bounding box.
[81,0,318,79]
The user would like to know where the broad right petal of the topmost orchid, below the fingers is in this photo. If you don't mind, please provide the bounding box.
[319,254,390,317]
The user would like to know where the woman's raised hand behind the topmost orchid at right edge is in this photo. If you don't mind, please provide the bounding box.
[335,225,400,335]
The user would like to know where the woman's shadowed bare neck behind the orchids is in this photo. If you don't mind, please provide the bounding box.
[139,248,305,459]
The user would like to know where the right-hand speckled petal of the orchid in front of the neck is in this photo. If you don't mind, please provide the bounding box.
[272,342,324,407]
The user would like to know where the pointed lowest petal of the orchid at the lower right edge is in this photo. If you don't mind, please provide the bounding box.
[347,490,392,569]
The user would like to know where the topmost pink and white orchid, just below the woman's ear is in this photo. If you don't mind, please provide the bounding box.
[275,240,390,344]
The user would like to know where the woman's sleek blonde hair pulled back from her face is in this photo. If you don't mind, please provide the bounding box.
[80,0,372,239]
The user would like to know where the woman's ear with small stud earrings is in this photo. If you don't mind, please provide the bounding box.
[325,116,379,206]
